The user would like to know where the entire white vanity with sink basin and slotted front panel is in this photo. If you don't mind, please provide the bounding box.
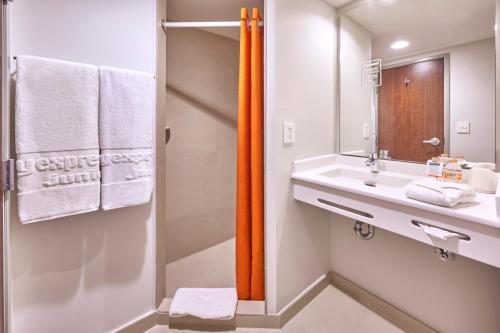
[292,155,500,268]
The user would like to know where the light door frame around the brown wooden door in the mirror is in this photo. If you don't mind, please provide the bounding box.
[375,53,450,158]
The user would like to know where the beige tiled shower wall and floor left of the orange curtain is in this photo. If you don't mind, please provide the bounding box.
[165,29,239,297]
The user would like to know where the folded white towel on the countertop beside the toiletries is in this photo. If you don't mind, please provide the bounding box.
[406,179,476,207]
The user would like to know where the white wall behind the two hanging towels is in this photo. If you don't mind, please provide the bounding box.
[10,0,156,333]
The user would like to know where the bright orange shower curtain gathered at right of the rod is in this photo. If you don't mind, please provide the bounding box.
[236,8,264,300]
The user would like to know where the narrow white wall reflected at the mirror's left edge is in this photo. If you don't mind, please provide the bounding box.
[339,15,373,153]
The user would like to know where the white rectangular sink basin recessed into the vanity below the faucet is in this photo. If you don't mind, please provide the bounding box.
[322,168,412,188]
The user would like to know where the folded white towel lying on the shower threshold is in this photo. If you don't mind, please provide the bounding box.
[169,288,238,320]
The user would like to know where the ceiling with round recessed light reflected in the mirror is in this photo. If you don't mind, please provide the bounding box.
[344,0,495,60]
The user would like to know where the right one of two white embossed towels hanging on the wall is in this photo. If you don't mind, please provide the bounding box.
[99,67,155,210]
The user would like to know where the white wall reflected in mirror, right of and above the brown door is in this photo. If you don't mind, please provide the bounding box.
[384,38,496,163]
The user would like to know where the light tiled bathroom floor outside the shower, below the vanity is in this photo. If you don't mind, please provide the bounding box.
[147,286,404,333]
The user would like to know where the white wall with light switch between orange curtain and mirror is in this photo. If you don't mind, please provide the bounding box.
[266,0,336,313]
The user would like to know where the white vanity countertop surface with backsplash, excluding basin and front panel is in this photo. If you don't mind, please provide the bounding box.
[292,155,500,228]
